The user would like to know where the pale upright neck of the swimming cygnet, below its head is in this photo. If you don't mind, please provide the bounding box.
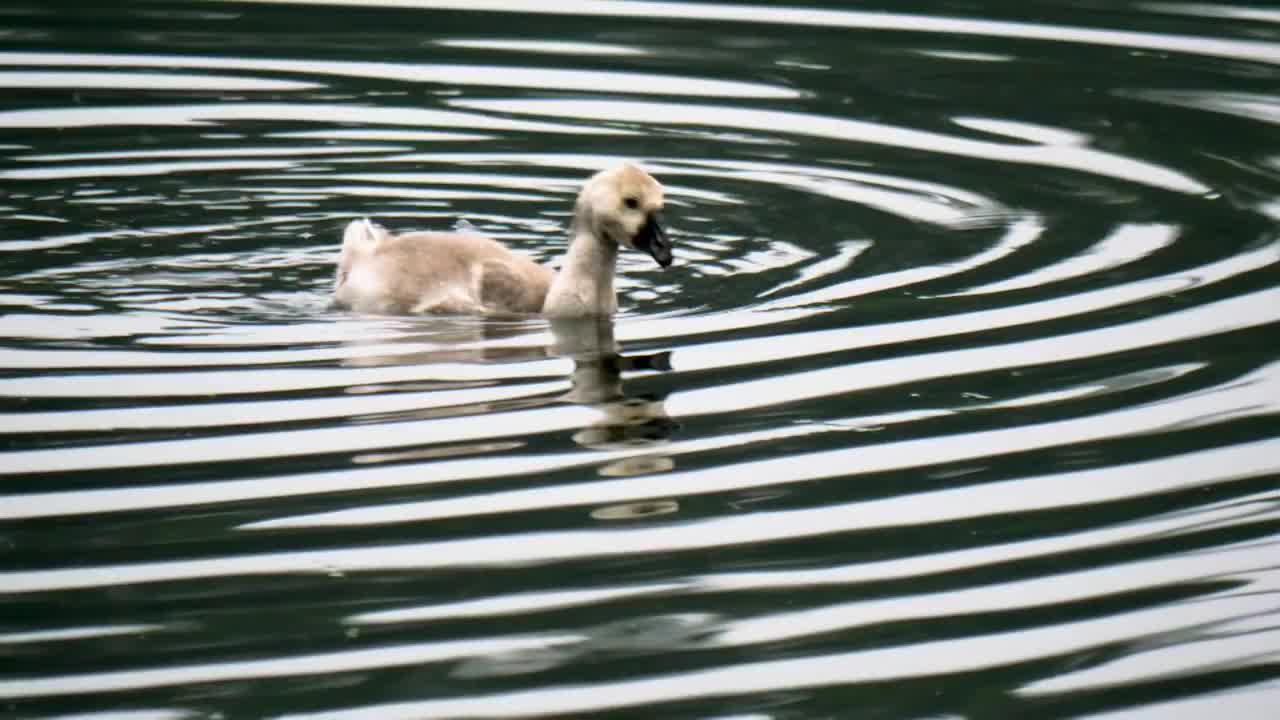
[543,229,618,318]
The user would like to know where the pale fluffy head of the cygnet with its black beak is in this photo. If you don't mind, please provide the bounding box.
[573,163,671,268]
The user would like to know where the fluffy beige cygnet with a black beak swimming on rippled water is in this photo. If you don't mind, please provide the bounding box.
[334,164,671,318]
